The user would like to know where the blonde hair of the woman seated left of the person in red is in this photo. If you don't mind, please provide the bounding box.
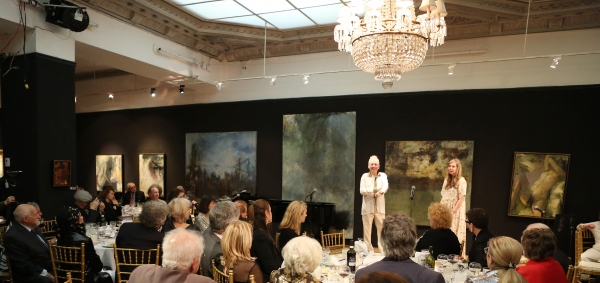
[487,236,527,283]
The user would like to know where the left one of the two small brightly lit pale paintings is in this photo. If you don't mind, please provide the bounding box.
[96,155,123,192]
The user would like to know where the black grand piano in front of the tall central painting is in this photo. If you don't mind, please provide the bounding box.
[232,194,335,241]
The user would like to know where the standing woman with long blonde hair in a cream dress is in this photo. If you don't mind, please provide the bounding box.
[434,159,467,254]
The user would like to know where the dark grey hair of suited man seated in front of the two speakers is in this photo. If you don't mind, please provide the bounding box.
[381,212,417,260]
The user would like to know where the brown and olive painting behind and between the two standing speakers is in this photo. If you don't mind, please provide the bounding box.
[385,141,474,226]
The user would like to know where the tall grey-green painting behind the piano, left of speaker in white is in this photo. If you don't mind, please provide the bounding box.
[282,112,356,239]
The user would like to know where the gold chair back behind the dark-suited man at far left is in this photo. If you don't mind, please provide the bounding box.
[48,241,85,283]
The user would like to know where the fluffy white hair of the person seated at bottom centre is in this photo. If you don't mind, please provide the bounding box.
[281,236,323,275]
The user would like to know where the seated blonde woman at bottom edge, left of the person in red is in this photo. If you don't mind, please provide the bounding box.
[466,237,524,283]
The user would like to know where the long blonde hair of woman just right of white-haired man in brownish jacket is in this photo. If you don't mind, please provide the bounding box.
[221,220,252,270]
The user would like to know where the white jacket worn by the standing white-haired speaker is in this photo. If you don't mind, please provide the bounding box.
[360,172,389,215]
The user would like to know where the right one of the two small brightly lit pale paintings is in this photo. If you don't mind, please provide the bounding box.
[138,153,165,195]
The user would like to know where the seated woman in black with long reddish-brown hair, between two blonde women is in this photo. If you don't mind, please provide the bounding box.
[250,199,284,278]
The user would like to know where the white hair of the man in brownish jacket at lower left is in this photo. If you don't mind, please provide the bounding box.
[161,228,204,270]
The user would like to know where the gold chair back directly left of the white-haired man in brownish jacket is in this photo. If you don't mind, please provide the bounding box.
[114,245,160,283]
